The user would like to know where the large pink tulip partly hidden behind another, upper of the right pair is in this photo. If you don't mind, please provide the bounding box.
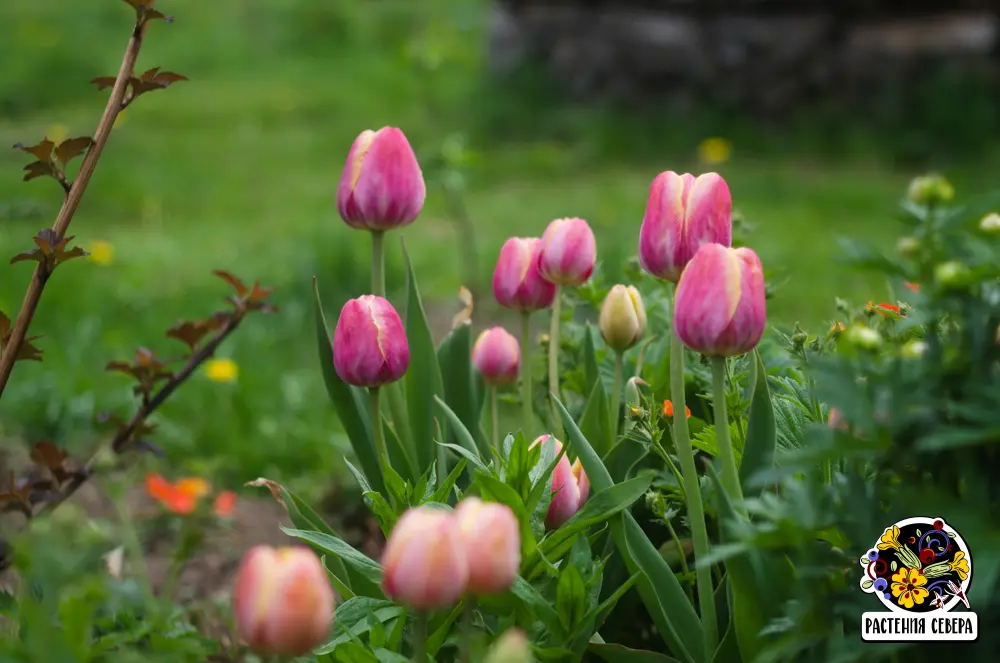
[639,171,733,283]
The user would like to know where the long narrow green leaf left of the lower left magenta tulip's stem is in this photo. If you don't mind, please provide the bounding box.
[313,276,385,492]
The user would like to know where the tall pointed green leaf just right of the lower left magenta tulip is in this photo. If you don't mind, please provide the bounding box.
[400,238,446,472]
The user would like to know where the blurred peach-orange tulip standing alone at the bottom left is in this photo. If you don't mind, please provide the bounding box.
[233,546,333,658]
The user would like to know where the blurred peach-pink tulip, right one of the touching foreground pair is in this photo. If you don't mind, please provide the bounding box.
[455,497,521,596]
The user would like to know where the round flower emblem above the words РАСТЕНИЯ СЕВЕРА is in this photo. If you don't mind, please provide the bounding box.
[860,518,972,613]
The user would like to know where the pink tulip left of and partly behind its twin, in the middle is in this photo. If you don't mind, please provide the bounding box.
[493,237,556,313]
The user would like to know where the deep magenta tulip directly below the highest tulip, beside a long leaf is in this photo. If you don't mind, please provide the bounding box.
[333,295,410,387]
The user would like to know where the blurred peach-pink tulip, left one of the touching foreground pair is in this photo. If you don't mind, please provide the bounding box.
[382,506,469,610]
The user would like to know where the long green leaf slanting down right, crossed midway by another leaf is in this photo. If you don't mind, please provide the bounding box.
[555,399,706,663]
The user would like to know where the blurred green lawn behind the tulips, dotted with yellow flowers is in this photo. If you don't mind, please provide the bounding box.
[0,0,998,487]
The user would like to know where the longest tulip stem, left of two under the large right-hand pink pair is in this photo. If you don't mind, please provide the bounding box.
[670,330,719,656]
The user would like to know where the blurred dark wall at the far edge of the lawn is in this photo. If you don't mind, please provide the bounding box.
[490,0,1000,115]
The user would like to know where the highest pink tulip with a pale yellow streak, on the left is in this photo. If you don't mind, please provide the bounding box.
[337,127,427,230]
